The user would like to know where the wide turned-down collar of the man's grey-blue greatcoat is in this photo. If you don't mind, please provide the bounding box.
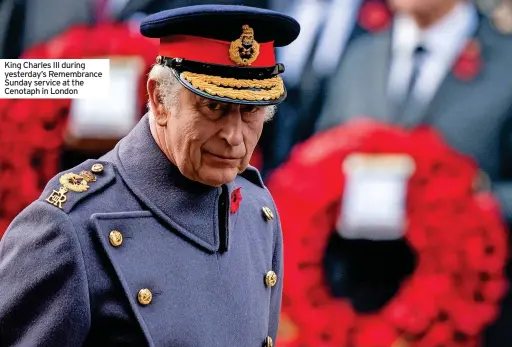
[114,115,234,252]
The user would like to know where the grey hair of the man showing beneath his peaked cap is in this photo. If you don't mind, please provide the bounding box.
[148,64,277,122]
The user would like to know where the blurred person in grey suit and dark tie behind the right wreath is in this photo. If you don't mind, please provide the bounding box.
[315,0,512,347]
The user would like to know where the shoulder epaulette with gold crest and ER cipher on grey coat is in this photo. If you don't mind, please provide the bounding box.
[39,160,115,213]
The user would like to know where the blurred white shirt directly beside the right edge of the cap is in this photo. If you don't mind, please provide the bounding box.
[277,0,362,86]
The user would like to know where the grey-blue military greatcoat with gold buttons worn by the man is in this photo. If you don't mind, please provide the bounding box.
[0,117,283,347]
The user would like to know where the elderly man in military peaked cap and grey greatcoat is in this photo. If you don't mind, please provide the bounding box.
[0,6,299,347]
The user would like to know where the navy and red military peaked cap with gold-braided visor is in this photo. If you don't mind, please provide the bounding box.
[141,5,300,105]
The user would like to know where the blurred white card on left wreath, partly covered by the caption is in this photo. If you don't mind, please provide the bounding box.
[68,57,144,139]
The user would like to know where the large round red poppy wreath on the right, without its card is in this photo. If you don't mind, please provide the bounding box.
[267,120,508,347]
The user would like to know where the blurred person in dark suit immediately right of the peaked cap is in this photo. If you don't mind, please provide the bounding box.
[260,0,391,174]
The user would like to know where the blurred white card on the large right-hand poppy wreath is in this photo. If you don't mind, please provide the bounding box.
[337,154,414,240]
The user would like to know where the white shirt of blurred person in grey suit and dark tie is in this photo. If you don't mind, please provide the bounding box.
[388,2,478,104]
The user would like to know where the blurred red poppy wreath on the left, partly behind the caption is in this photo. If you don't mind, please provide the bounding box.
[0,23,158,237]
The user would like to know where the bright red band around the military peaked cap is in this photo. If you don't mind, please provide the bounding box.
[158,35,276,67]
